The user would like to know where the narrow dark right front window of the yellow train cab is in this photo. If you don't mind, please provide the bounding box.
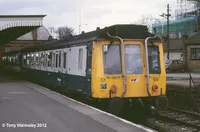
[148,45,160,74]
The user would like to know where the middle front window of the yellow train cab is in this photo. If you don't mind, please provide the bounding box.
[125,44,142,74]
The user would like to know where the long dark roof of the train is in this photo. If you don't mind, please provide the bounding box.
[17,24,153,52]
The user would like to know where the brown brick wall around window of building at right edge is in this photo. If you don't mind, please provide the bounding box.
[187,45,200,72]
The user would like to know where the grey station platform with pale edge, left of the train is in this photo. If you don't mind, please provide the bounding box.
[0,74,154,132]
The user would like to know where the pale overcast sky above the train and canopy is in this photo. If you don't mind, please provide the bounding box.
[0,0,176,33]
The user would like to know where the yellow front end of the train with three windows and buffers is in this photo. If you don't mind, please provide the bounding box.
[91,27,168,115]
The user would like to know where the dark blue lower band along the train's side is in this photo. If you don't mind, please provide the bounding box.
[23,68,91,96]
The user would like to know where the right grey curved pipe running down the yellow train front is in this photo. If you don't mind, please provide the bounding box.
[145,36,157,96]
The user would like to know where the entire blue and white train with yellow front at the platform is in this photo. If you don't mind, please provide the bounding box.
[2,25,167,115]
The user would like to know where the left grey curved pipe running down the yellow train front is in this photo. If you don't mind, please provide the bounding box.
[106,32,126,98]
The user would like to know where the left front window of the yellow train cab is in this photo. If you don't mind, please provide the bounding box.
[103,44,122,74]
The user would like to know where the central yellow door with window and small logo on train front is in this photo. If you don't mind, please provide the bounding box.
[125,42,146,97]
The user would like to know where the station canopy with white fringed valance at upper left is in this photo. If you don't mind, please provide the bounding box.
[0,15,46,45]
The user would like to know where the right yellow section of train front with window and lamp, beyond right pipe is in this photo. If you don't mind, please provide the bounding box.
[146,41,166,96]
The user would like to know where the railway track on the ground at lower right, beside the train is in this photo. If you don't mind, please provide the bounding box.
[156,108,200,130]
